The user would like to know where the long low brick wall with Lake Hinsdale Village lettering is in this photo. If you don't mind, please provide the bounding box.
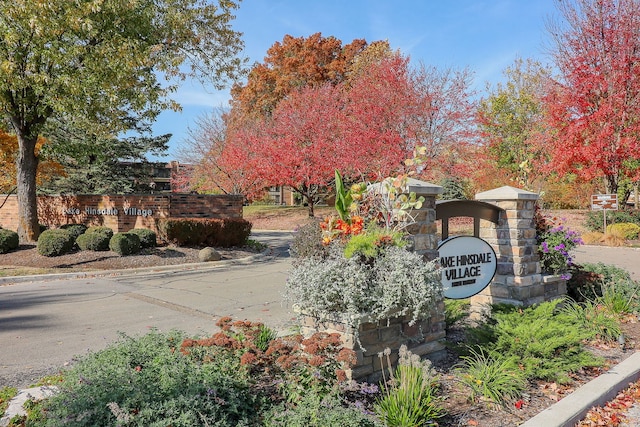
[0,193,243,232]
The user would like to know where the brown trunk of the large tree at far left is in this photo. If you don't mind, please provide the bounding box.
[16,132,40,243]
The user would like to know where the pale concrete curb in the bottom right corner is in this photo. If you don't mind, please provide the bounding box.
[520,351,640,427]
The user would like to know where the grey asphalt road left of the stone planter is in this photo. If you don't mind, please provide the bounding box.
[0,232,294,387]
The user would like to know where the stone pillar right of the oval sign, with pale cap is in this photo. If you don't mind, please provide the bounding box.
[471,186,550,311]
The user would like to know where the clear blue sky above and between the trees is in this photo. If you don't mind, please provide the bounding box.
[154,0,556,161]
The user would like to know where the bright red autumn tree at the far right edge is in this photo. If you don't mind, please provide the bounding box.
[546,0,640,201]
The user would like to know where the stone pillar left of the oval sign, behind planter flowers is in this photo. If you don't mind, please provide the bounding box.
[406,178,442,261]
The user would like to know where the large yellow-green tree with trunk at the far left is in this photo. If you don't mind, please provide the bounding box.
[0,0,242,241]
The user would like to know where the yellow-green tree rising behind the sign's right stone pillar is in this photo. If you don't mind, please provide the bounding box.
[478,58,551,189]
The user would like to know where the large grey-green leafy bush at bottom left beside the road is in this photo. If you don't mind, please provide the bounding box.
[44,332,264,427]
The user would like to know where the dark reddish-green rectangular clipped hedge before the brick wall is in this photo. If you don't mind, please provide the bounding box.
[156,218,251,248]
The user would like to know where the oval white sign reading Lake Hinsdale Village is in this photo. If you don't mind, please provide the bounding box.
[438,236,498,299]
